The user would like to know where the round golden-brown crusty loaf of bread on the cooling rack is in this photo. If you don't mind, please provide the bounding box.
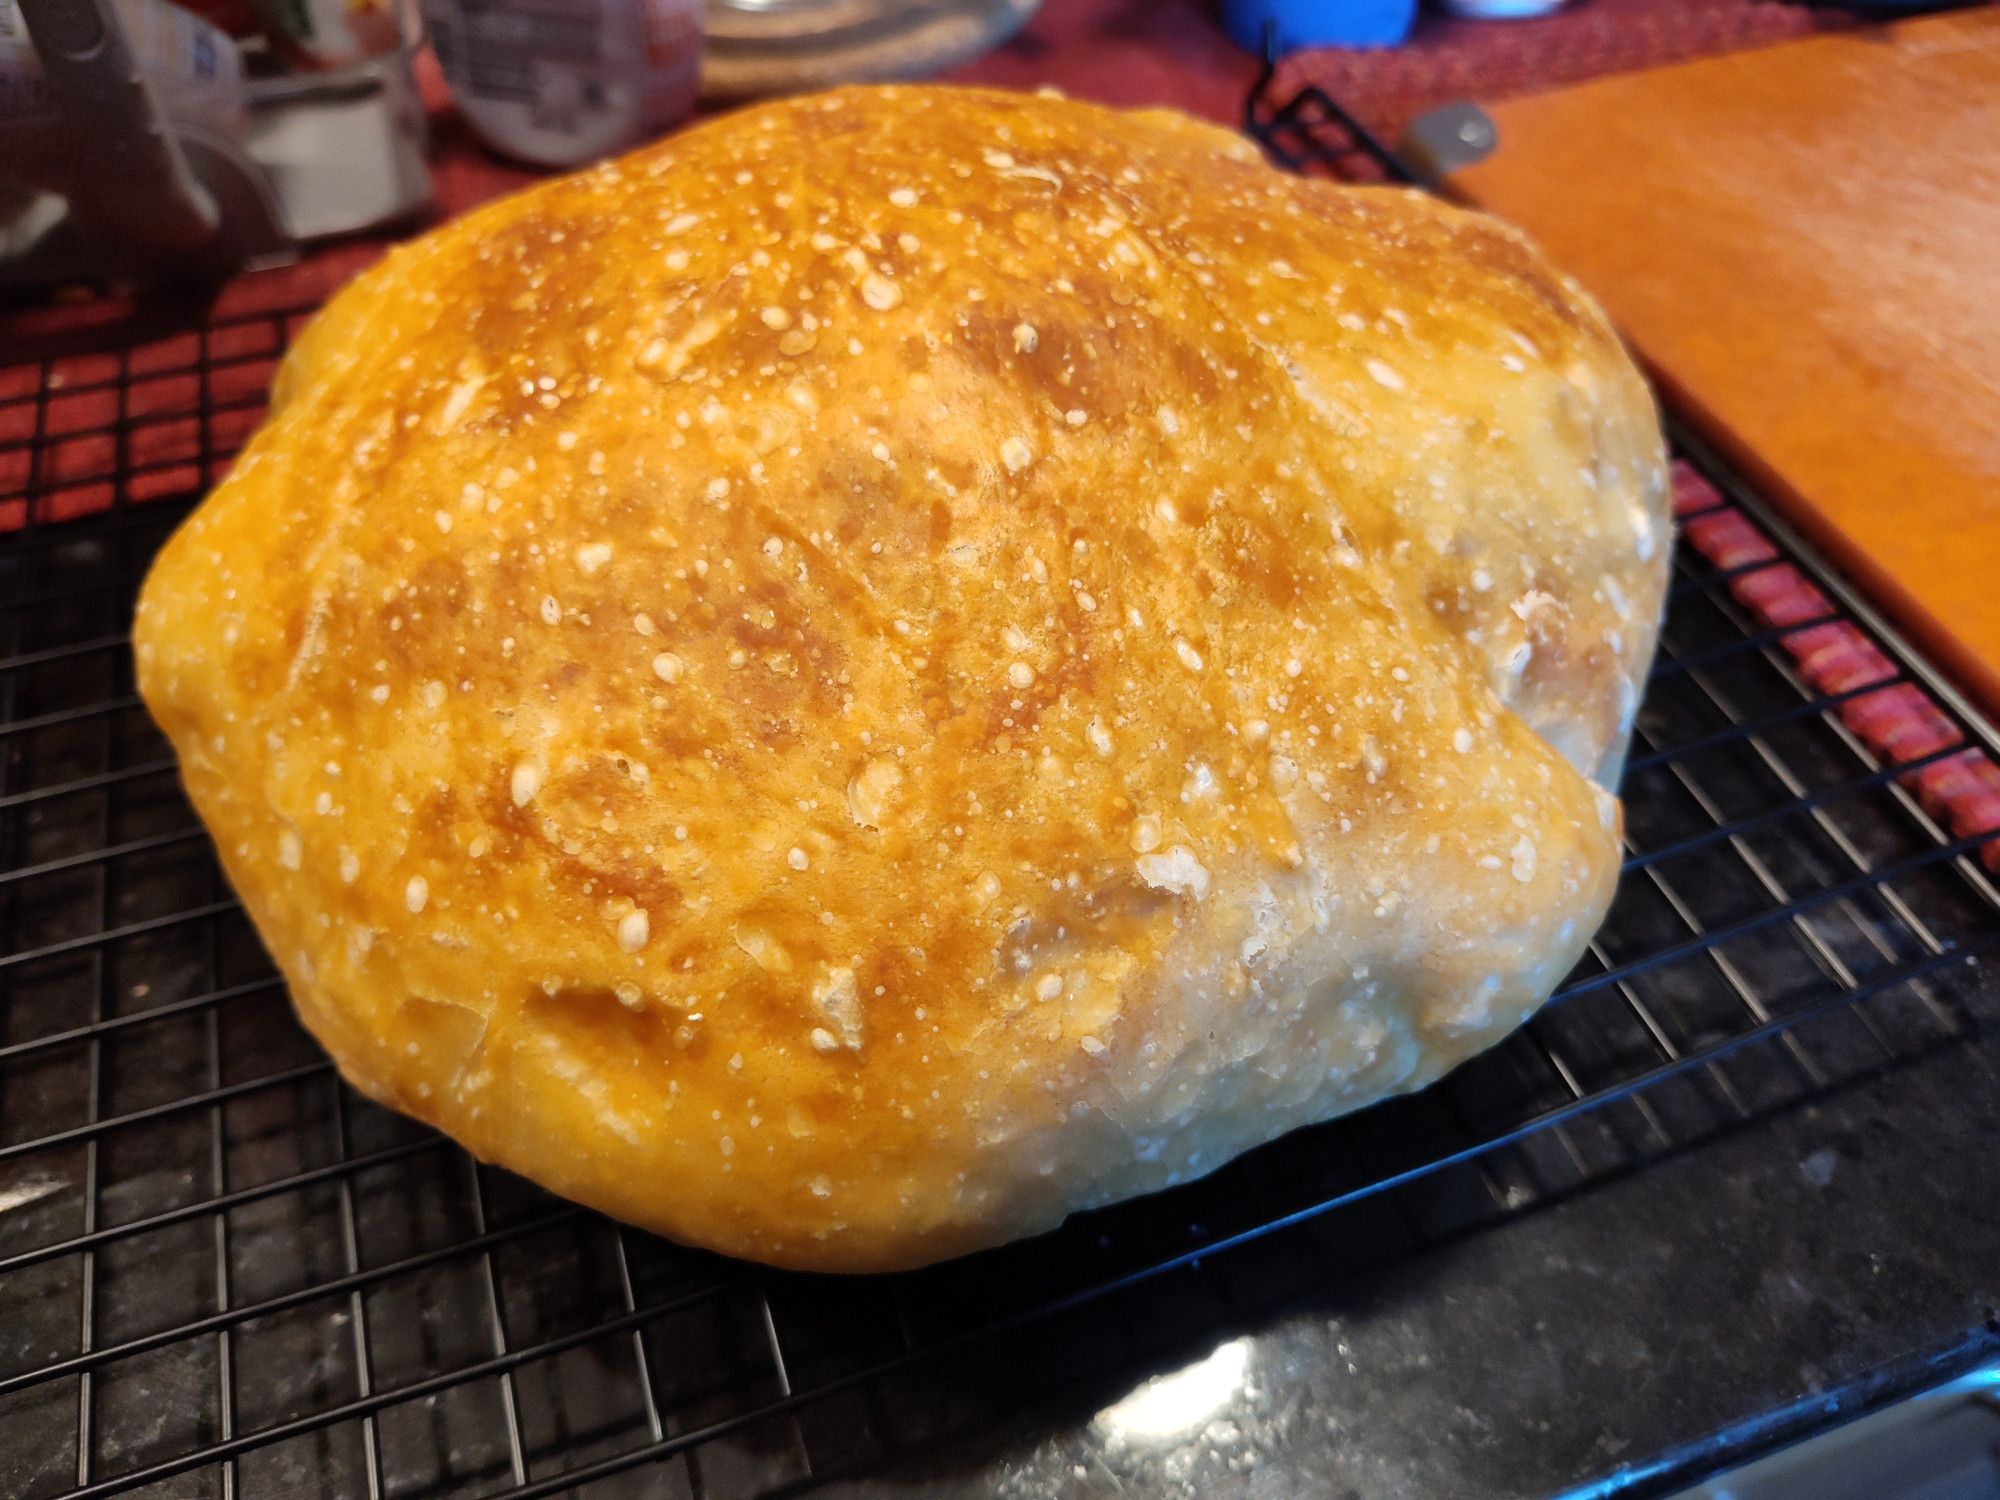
[136,88,1670,1270]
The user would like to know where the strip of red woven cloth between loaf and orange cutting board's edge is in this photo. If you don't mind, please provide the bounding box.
[1674,462,2000,872]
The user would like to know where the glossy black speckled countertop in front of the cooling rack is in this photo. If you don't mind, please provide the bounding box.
[814,1016,2000,1500]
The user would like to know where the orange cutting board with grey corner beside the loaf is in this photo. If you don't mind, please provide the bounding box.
[1448,8,2000,708]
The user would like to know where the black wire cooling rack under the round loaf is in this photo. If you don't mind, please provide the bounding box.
[0,96,2000,1500]
